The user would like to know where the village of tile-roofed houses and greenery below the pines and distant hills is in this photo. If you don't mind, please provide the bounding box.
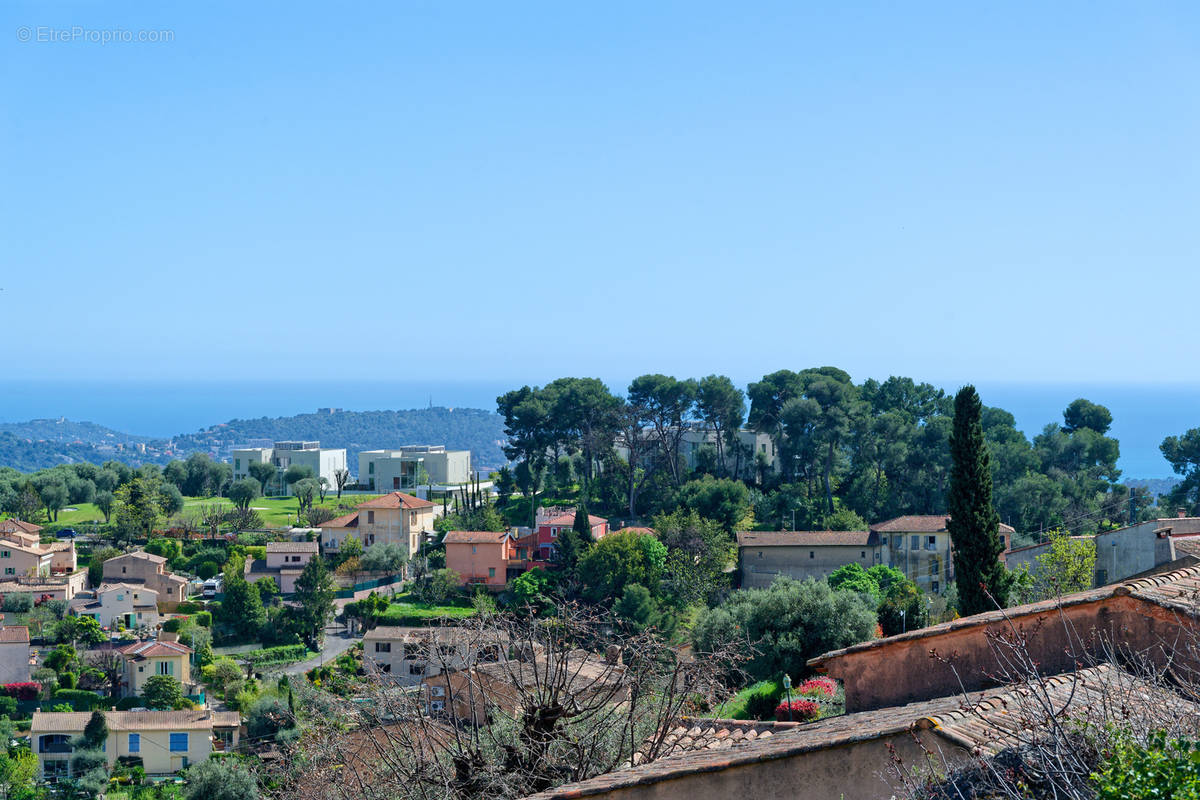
[0,376,1200,800]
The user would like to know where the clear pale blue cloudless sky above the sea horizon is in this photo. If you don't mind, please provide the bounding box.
[0,0,1200,384]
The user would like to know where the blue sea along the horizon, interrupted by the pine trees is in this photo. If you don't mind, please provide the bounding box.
[0,378,1200,479]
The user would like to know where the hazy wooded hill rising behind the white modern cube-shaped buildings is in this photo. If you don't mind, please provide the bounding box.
[172,408,506,471]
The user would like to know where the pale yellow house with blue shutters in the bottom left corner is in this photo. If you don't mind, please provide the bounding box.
[29,709,241,781]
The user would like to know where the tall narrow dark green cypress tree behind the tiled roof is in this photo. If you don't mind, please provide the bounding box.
[947,386,1008,616]
